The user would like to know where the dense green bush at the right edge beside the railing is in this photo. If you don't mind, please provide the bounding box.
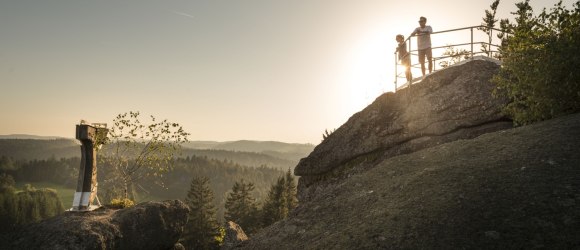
[492,0,580,125]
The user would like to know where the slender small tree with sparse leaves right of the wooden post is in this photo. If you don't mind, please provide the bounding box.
[100,111,189,199]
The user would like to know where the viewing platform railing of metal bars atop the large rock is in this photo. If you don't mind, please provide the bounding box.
[395,25,502,91]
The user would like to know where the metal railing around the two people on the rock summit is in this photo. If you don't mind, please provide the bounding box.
[394,25,502,91]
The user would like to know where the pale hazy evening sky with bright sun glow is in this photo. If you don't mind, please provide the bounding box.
[0,0,574,144]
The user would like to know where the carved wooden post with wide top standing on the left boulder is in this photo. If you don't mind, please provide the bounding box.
[71,123,109,211]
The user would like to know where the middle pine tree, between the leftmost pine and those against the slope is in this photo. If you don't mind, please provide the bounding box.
[224,179,260,234]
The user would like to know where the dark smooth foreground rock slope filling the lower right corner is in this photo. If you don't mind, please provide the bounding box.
[239,114,580,250]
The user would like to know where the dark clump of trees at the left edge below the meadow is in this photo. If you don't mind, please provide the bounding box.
[0,174,64,233]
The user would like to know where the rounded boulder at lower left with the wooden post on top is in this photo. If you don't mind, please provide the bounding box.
[5,200,189,249]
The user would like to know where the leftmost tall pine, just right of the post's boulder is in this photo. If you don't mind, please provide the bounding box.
[182,177,219,249]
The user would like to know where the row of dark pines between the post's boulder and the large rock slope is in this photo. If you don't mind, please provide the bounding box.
[180,171,298,249]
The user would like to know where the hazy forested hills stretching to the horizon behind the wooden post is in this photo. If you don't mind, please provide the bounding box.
[0,139,311,230]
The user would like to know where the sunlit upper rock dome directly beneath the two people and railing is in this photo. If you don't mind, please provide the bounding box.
[294,60,512,201]
